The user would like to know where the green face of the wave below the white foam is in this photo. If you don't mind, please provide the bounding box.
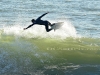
[0,34,100,75]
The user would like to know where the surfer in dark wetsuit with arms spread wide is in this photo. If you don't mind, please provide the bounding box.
[24,12,52,32]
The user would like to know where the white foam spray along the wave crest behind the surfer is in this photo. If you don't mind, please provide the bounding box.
[4,21,77,39]
